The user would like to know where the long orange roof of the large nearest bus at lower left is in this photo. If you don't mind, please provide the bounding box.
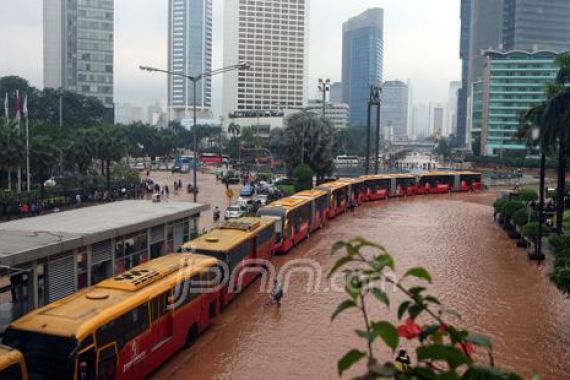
[10,253,218,340]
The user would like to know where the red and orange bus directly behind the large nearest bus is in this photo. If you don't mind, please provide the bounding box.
[182,218,275,307]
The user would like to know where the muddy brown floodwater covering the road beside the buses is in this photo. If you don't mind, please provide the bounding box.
[153,187,570,380]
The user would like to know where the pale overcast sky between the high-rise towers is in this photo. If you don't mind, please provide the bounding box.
[0,0,461,114]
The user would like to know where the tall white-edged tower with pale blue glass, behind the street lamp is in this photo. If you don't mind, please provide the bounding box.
[167,0,212,120]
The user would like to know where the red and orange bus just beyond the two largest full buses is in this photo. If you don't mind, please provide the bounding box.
[257,197,312,253]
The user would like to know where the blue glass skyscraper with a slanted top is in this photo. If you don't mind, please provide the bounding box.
[342,8,384,126]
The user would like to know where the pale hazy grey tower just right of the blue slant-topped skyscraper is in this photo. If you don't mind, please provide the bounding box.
[380,80,408,139]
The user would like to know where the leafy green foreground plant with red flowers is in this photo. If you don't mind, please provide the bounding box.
[328,238,521,380]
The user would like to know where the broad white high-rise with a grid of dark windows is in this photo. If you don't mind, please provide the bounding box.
[223,0,309,122]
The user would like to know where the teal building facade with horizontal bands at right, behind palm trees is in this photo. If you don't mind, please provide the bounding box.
[480,50,558,156]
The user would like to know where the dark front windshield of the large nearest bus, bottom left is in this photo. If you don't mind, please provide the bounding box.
[2,329,77,380]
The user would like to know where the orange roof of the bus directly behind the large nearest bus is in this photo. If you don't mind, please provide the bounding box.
[182,217,275,253]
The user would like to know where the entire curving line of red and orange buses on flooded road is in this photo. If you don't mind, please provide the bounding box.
[0,172,482,380]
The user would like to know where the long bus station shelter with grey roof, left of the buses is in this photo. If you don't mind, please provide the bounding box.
[0,200,204,326]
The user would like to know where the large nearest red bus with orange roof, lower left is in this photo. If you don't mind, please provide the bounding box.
[3,253,220,380]
